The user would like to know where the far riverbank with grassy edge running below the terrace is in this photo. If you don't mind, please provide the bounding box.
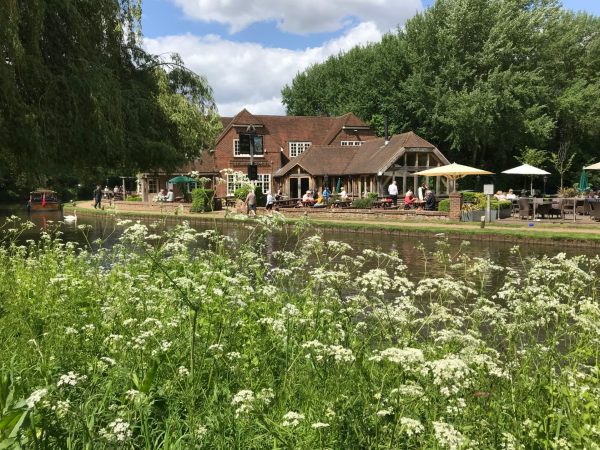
[64,202,600,248]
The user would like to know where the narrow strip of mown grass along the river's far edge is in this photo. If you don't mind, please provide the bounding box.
[65,206,600,245]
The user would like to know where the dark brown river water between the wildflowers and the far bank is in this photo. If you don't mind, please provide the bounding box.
[0,208,596,284]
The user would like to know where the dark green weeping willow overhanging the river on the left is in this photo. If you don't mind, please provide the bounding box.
[0,0,220,192]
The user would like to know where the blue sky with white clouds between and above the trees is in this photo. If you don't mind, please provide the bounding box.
[142,0,600,116]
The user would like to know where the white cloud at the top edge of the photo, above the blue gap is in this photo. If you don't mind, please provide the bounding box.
[171,0,423,34]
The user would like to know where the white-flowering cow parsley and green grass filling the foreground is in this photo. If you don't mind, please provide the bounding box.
[0,215,600,448]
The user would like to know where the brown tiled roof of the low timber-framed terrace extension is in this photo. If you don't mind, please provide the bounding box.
[274,131,449,177]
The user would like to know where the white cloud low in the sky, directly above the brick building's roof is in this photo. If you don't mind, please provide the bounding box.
[144,22,381,116]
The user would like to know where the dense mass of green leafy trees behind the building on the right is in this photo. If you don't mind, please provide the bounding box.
[282,0,600,186]
